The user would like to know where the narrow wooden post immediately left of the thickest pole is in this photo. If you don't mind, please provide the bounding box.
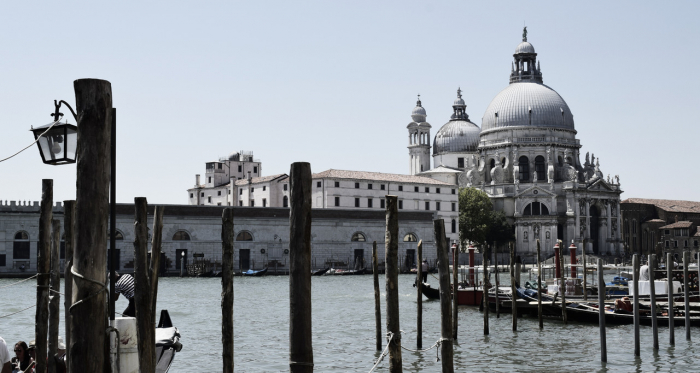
[63,201,75,372]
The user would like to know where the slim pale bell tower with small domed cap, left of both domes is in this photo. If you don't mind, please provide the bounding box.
[406,95,431,175]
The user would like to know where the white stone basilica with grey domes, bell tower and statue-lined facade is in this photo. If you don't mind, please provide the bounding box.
[407,30,622,260]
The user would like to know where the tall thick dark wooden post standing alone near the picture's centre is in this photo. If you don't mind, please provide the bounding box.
[289,162,314,373]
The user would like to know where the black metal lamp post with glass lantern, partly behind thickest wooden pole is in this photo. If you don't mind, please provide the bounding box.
[31,100,117,321]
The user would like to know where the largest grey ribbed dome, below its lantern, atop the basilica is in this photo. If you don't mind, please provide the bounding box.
[481,82,574,131]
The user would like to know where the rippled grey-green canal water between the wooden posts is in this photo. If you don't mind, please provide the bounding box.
[0,275,700,373]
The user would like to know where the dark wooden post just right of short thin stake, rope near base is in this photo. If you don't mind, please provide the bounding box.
[384,195,403,373]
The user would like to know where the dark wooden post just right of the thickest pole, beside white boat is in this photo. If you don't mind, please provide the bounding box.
[134,197,156,372]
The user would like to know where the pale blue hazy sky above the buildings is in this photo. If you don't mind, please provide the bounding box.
[0,0,700,204]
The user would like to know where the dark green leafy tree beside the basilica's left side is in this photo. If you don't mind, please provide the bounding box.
[459,188,493,248]
